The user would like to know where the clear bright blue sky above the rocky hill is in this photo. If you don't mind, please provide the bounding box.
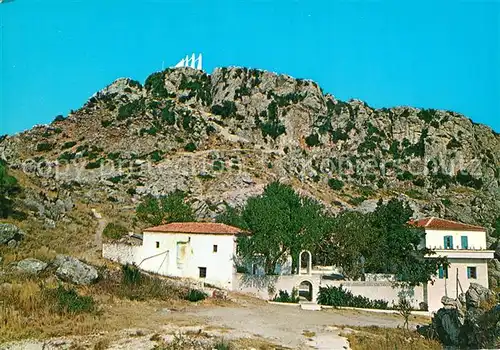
[0,0,500,134]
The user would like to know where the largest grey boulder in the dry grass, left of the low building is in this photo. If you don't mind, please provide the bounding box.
[54,255,99,284]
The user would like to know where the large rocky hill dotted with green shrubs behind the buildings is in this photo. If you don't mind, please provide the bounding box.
[0,67,500,282]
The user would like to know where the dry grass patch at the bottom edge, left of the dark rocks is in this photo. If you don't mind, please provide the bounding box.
[341,326,442,350]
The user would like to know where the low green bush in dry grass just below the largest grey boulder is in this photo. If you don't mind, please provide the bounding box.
[46,285,96,314]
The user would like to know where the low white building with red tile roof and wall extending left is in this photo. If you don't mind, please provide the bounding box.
[103,222,248,290]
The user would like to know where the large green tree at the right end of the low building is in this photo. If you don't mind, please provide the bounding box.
[218,182,325,274]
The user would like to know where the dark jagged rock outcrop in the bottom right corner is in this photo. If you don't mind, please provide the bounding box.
[426,283,500,349]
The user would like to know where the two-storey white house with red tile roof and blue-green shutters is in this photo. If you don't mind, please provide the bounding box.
[412,217,494,311]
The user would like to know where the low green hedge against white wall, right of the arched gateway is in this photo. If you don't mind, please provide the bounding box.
[318,285,388,309]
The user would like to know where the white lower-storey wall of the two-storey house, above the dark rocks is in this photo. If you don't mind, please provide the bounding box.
[428,258,488,311]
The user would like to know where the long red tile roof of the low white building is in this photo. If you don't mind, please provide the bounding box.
[144,222,249,235]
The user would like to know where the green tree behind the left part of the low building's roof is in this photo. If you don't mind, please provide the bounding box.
[136,190,195,225]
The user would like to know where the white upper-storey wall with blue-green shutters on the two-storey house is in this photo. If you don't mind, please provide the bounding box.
[425,229,486,249]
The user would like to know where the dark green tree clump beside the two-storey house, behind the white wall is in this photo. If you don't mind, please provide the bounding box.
[315,199,447,285]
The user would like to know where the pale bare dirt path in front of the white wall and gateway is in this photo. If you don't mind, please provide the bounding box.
[188,304,418,350]
